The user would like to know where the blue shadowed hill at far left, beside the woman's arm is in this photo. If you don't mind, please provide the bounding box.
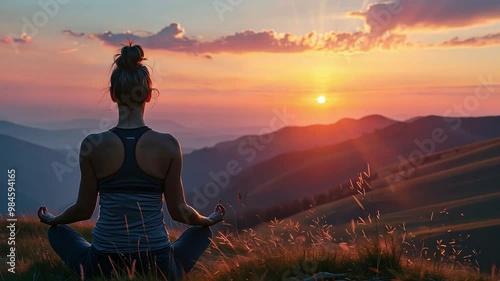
[0,135,80,215]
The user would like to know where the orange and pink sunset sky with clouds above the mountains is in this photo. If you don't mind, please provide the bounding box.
[0,0,500,127]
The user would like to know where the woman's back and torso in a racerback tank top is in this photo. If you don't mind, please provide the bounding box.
[91,126,177,254]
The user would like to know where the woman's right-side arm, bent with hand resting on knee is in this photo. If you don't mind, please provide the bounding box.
[163,135,223,226]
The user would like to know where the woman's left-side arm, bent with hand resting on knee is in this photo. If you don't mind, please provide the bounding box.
[38,137,98,225]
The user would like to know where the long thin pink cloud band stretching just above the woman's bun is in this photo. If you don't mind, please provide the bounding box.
[64,23,406,55]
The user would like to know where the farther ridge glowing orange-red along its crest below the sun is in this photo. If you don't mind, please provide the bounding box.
[183,115,396,190]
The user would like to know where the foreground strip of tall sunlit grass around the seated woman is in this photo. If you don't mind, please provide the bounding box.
[0,219,498,281]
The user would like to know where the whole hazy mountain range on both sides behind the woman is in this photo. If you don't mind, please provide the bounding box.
[0,115,500,217]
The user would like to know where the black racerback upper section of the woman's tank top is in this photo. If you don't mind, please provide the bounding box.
[98,126,163,193]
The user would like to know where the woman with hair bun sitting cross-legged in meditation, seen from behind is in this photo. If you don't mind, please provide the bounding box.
[38,43,225,281]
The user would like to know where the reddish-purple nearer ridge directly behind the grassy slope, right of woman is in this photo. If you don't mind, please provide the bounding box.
[187,116,500,217]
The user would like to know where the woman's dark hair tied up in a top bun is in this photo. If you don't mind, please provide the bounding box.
[109,42,158,108]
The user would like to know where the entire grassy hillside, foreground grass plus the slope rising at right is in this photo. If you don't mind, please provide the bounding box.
[0,139,500,281]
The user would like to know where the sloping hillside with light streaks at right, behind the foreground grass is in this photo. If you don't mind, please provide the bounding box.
[252,139,500,270]
